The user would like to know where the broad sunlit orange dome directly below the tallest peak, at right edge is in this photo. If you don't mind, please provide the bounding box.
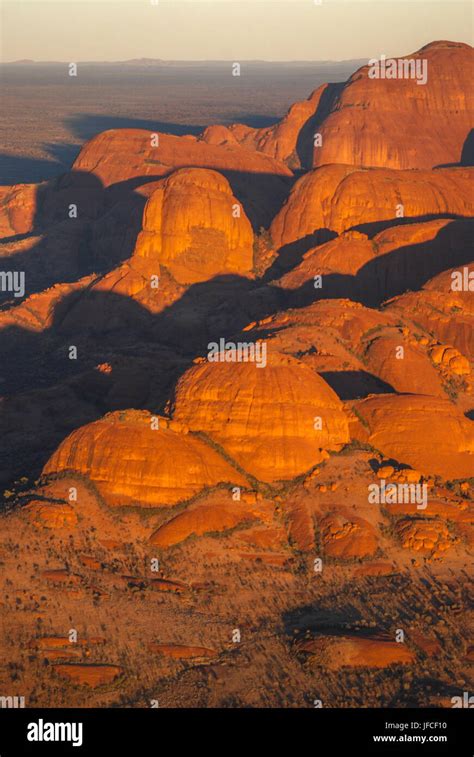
[270,165,473,252]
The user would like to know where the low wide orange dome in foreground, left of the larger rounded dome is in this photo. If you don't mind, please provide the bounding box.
[43,410,245,507]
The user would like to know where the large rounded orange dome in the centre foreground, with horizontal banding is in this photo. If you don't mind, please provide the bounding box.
[174,352,349,482]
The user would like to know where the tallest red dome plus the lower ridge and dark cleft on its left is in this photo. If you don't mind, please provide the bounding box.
[223,41,474,169]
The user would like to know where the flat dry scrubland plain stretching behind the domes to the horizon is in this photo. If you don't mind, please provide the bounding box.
[0,61,362,185]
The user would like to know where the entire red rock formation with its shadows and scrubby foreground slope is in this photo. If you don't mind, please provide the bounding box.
[0,37,474,707]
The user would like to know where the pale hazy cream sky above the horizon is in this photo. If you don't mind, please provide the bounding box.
[0,0,473,62]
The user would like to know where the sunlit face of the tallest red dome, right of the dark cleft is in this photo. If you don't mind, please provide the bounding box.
[313,42,474,169]
